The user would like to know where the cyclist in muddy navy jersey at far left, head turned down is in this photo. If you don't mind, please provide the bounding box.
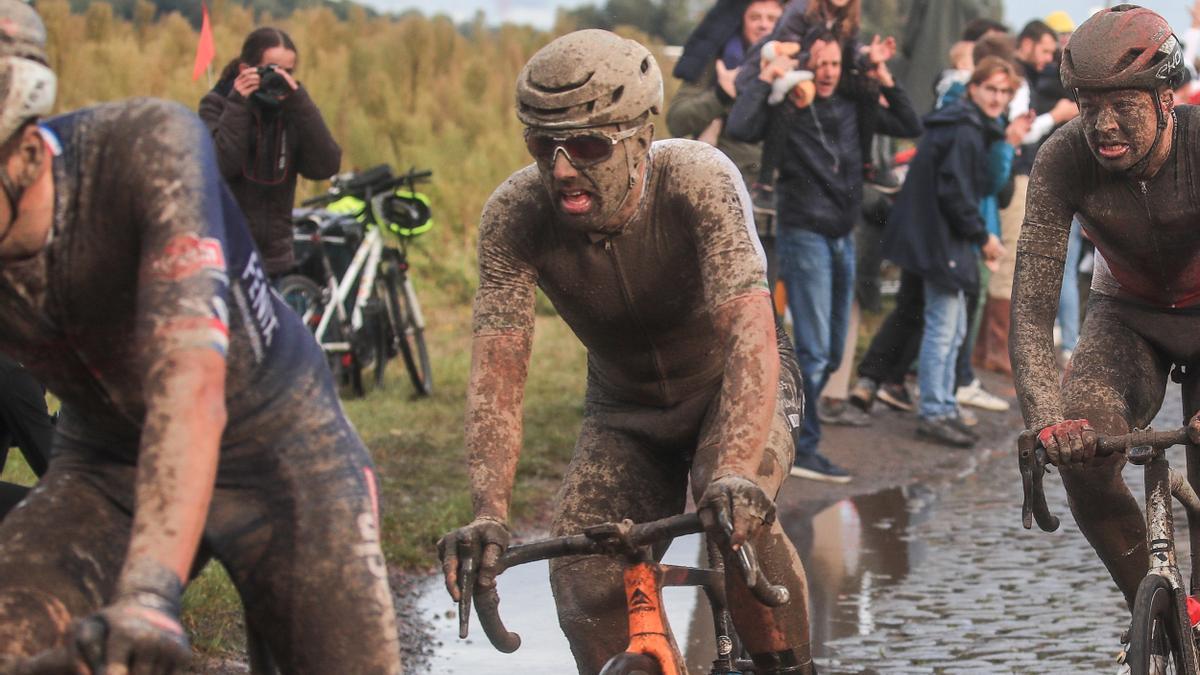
[0,0,401,674]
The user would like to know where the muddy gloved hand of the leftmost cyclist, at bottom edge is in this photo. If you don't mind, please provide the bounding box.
[72,562,192,675]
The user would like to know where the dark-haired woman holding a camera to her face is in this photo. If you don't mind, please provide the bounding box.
[200,28,342,279]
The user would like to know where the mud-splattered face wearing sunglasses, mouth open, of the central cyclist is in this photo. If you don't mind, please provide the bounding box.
[527,124,654,234]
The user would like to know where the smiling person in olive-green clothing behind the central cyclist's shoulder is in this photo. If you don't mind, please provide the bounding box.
[667,0,784,285]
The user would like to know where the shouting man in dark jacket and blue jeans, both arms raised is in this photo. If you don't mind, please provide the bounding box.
[728,30,920,480]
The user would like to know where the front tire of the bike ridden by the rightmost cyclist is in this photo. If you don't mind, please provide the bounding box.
[1126,574,1190,675]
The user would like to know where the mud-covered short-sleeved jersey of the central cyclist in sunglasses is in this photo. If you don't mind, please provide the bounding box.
[474,139,768,406]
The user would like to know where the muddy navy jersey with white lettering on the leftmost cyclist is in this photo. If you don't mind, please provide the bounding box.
[0,98,319,446]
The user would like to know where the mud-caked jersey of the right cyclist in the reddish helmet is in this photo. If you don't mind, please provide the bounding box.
[1018,106,1200,307]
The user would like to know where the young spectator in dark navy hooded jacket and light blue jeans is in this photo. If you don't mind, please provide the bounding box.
[883,58,1019,447]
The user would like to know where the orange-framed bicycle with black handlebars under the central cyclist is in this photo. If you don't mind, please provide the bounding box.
[458,513,790,675]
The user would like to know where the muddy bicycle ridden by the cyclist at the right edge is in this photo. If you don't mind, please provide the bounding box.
[1016,426,1200,675]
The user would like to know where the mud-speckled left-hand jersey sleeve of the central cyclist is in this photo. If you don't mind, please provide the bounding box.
[473,167,544,336]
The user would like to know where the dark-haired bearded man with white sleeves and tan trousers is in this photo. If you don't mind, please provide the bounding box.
[974,19,1079,375]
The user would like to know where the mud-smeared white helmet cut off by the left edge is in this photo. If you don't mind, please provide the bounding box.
[0,0,58,142]
